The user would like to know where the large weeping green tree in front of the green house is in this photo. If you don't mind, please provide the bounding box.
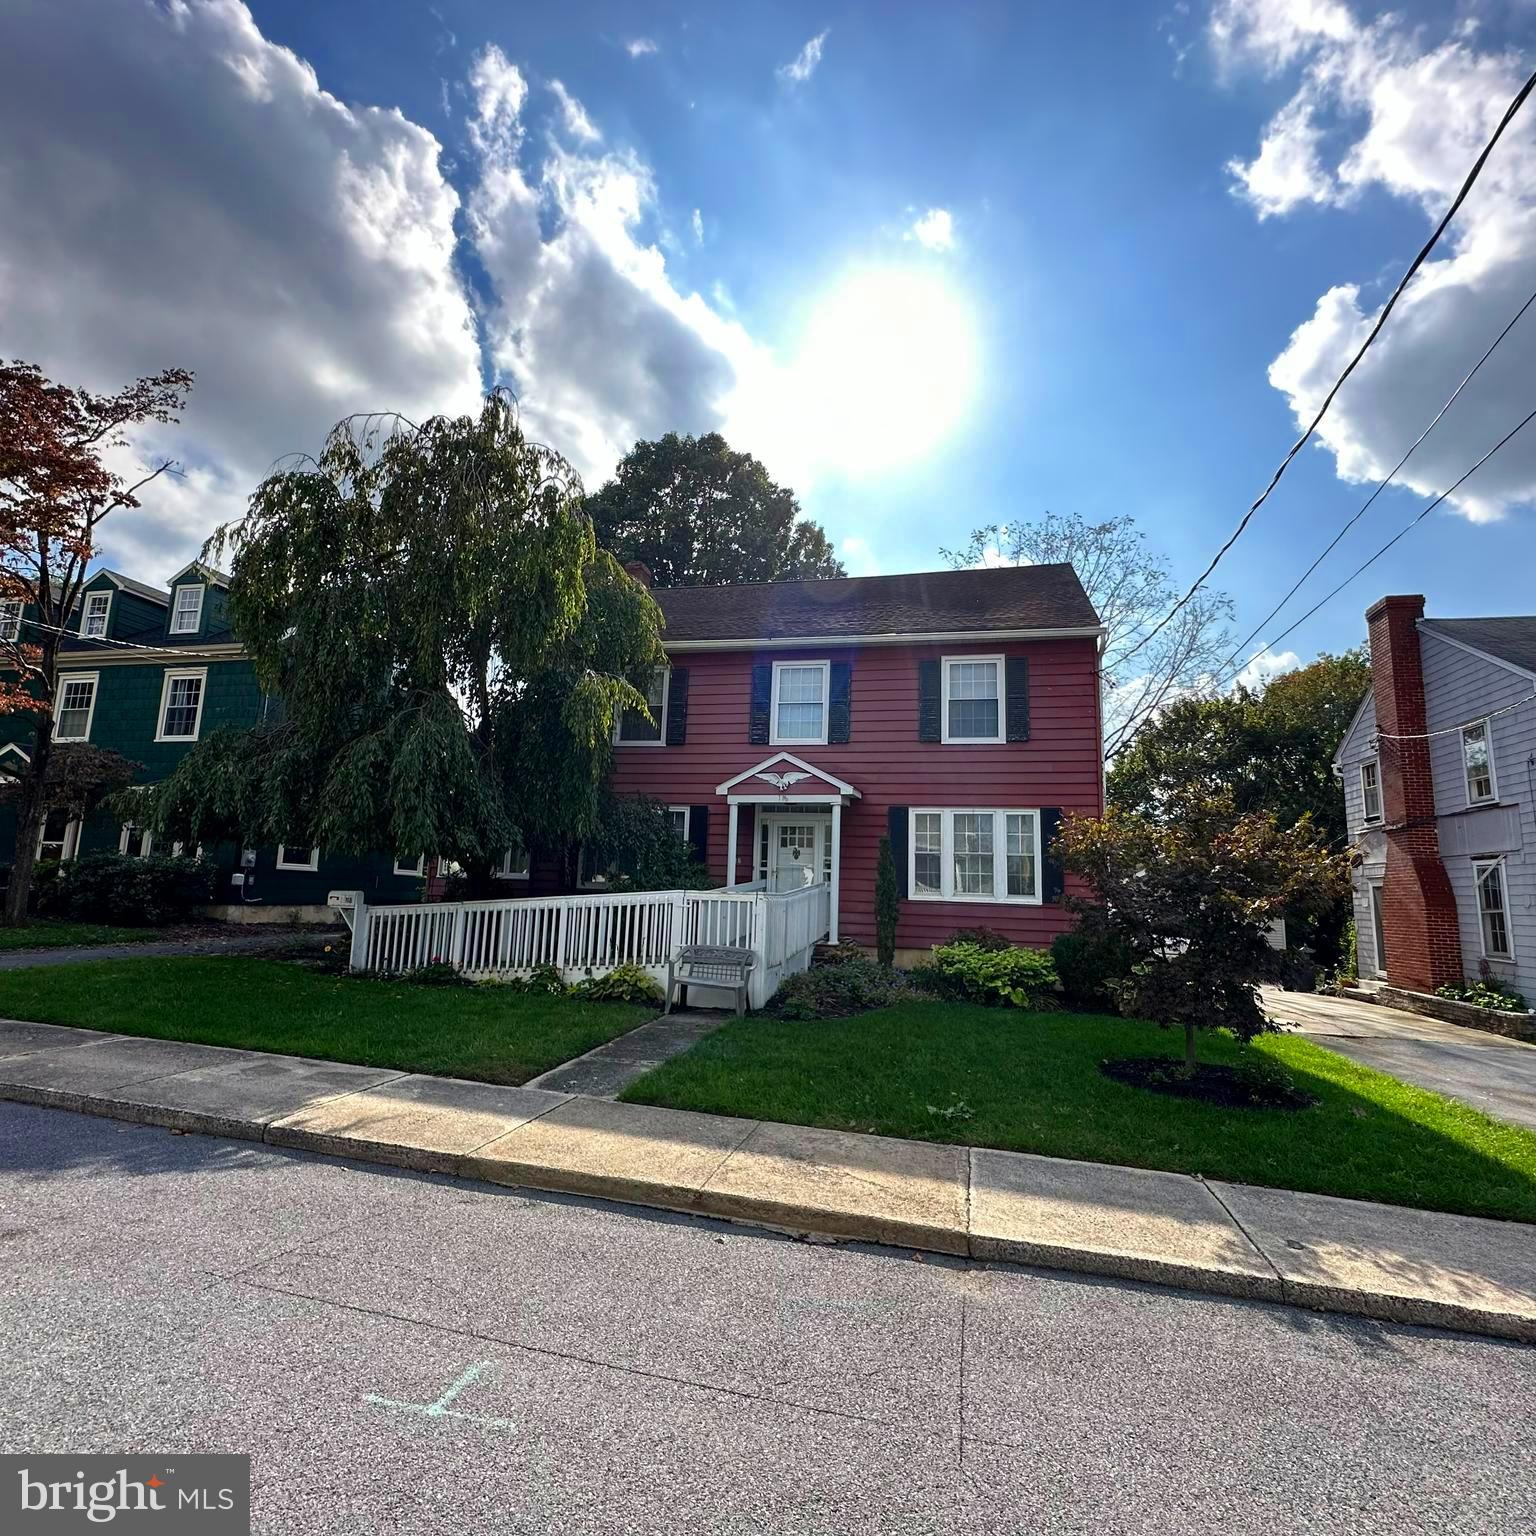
[151,392,664,889]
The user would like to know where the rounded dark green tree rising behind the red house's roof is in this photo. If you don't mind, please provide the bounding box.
[587,432,848,587]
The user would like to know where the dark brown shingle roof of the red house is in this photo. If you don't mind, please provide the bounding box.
[656,565,1098,644]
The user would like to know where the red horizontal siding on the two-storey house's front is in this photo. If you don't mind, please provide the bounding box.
[613,641,1103,949]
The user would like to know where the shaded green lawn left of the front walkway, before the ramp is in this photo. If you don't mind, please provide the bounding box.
[0,955,656,1083]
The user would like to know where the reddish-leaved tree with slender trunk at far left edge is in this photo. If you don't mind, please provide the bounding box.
[0,359,192,923]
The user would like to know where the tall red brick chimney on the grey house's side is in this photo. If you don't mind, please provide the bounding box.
[1366,596,1464,992]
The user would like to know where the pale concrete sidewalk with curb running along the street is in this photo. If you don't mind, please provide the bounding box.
[0,1021,1536,1342]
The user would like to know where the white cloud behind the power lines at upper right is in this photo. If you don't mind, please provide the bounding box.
[1210,0,1536,522]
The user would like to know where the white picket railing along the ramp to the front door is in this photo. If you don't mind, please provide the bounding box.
[330,885,831,1008]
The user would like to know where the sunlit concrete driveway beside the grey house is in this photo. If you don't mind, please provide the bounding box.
[1263,986,1536,1130]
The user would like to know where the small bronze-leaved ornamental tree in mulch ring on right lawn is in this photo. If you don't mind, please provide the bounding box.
[1058,786,1349,1072]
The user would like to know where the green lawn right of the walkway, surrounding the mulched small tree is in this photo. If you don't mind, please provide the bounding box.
[622,1003,1536,1221]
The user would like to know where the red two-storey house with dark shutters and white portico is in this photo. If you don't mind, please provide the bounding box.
[586,565,1103,958]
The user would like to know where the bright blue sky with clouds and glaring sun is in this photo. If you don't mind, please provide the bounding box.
[0,0,1536,675]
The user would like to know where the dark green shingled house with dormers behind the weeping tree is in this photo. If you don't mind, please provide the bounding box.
[0,562,427,922]
